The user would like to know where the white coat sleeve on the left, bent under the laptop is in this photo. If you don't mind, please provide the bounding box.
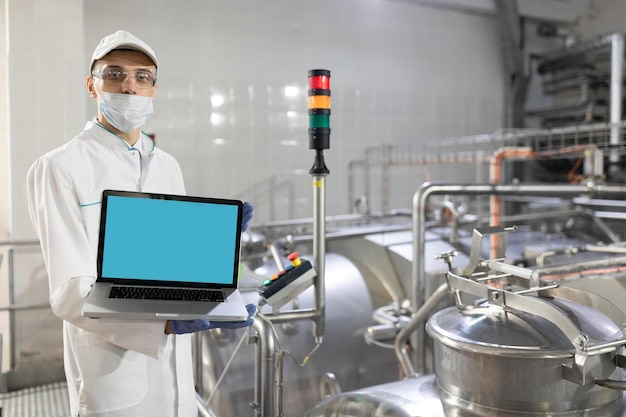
[27,156,167,358]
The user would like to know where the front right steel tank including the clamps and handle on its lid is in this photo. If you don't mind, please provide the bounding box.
[426,227,626,415]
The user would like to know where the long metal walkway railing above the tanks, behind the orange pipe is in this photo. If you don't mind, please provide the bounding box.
[348,121,626,212]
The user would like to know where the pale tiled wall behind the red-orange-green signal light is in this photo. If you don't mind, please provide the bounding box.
[80,0,503,221]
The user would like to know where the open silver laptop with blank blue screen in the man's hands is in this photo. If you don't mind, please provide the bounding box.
[82,190,248,321]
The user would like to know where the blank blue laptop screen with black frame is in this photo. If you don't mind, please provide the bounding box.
[98,190,242,288]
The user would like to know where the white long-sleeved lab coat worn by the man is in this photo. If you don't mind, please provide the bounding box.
[27,122,197,417]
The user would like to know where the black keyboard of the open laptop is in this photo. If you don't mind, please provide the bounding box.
[109,286,224,302]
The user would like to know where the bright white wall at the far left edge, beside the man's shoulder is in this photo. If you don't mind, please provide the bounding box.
[0,0,85,370]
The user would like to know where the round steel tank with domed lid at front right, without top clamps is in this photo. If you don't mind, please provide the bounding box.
[426,299,624,416]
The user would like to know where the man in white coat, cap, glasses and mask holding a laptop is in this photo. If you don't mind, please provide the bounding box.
[27,31,254,417]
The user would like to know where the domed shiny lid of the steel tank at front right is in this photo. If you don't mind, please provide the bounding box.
[426,298,623,357]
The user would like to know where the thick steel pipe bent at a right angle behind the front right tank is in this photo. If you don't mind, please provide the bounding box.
[411,182,626,372]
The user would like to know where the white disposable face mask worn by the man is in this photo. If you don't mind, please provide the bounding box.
[98,92,154,133]
